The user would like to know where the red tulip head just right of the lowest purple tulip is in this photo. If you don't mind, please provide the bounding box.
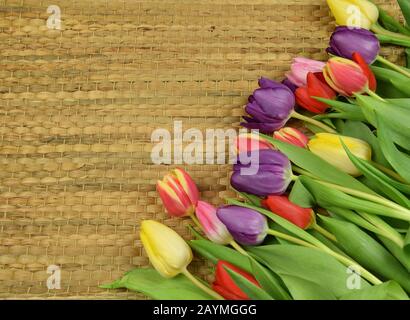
[262,196,315,230]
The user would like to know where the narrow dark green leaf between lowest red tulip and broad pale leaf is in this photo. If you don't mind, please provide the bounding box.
[249,257,291,300]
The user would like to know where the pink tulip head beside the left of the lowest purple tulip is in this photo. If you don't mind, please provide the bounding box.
[196,201,233,245]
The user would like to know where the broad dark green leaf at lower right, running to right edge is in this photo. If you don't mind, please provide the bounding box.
[320,216,410,292]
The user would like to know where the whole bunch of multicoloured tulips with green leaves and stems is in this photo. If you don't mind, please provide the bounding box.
[103,0,410,300]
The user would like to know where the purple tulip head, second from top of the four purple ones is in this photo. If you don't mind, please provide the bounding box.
[241,78,295,133]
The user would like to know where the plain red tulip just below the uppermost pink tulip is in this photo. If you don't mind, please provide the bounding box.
[295,73,336,113]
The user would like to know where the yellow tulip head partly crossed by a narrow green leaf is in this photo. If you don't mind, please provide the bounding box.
[308,133,372,176]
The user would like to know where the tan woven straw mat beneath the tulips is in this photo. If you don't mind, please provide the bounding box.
[0,0,403,299]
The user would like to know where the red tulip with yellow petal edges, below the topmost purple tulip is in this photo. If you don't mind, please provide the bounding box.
[323,57,369,97]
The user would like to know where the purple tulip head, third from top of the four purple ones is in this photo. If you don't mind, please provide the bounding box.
[231,150,292,196]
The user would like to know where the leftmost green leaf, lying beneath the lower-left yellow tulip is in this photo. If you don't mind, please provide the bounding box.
[101,268,213,300]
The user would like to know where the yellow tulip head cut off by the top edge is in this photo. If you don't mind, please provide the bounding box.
[327,0,379,29]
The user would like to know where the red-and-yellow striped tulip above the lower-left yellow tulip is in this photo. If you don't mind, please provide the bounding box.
[157,169,199,217]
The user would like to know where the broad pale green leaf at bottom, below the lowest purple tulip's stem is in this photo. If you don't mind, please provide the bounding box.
[249,245,369,298]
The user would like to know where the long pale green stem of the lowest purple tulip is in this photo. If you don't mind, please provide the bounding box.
[268,229,382,285]
